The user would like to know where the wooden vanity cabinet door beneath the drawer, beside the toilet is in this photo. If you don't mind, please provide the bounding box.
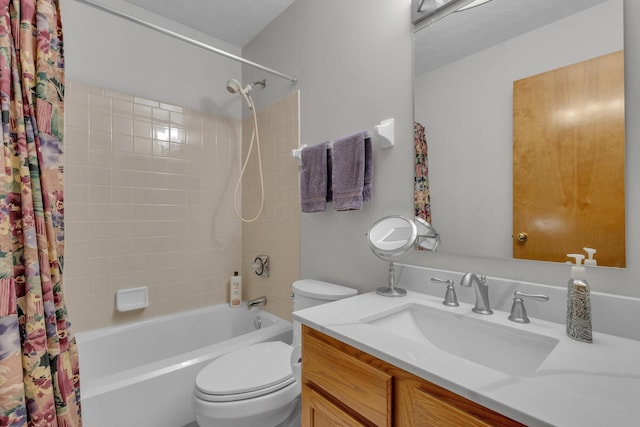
[302,385,364,427]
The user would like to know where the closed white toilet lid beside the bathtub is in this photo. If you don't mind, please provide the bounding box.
[196,341,295,401]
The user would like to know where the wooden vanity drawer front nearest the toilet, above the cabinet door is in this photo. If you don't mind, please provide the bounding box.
[302,328,392,426]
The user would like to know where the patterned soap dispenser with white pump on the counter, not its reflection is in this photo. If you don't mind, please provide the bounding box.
[567,254,593,343]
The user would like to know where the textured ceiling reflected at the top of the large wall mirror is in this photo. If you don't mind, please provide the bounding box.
[414,0,606,75]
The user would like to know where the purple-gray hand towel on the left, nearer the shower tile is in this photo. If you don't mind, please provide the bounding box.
[300,142,327,212]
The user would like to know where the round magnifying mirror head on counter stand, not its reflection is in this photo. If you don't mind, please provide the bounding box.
[369,215,418,262]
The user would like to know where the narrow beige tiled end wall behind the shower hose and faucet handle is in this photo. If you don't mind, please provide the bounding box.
[242,91,300,320]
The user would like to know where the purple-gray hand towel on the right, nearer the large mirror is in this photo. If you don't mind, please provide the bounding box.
[331,131,365,211]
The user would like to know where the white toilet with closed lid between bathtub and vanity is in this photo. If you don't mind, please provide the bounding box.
[194,280,358,427]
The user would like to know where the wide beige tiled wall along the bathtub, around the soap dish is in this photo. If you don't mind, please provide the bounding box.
[64,82,242,332]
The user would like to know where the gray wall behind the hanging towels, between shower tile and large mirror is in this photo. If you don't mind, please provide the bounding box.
[243,0,413,290]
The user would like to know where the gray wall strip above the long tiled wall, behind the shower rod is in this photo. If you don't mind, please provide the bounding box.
[61,0,242,118]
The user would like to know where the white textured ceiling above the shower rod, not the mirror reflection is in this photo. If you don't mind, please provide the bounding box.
[127,0,294,47]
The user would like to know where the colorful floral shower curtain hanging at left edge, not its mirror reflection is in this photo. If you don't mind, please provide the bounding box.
[0,0,82,427]
